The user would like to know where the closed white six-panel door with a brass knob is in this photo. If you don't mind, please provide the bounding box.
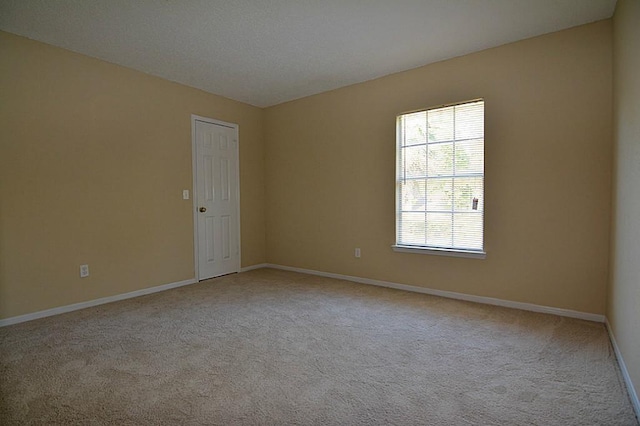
[194,118,240,280]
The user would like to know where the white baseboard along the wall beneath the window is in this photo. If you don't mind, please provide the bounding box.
[266,263,605,322]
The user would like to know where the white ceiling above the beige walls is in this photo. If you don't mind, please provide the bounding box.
[0,0,616,107]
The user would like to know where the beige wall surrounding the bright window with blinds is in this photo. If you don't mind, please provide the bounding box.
[265,20,612,314]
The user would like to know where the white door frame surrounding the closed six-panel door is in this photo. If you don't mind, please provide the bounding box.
[191,114,242,281]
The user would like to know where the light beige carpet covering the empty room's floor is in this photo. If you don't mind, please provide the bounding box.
[0,269,637,425]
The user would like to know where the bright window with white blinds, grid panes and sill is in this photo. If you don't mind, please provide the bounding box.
[393,100,484,258]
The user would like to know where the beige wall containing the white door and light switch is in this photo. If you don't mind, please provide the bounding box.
[0,33,265,318]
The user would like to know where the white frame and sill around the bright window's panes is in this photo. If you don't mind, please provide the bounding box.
[391,99,487,259]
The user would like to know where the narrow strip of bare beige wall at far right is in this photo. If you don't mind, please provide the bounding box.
[607,0,640,406]
